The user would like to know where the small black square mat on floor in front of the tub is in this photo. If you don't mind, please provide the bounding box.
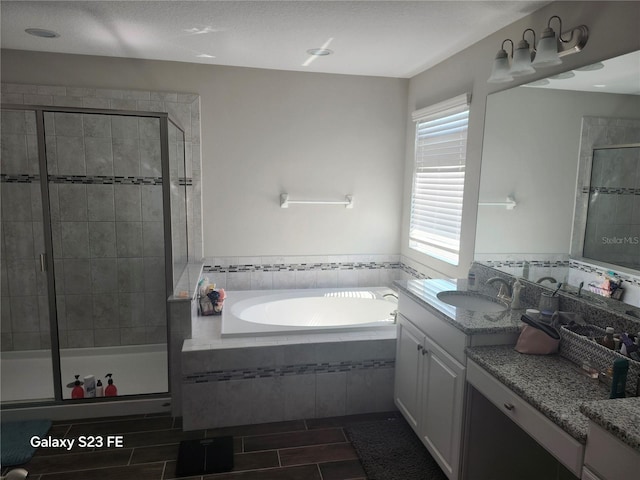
[176,437,233,477]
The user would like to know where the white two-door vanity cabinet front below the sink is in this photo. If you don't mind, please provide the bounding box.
[394,295,466,480]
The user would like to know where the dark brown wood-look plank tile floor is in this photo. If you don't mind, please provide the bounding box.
[3,412,400,480]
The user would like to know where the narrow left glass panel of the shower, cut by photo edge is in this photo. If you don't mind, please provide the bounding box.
[0,109,55,403]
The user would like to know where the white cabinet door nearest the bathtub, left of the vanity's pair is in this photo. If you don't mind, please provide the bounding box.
[394,314,424,432]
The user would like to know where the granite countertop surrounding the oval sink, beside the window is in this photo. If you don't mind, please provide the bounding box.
[394,279,524,335]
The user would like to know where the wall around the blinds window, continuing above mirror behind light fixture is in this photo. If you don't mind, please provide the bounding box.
[401,2,640,277]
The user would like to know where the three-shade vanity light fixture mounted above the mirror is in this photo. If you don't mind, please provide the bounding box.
[488,15,589,83]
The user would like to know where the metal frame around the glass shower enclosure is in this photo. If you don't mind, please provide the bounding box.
[0,103,188,404]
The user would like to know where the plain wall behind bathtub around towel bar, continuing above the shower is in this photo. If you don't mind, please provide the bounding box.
[2,50,408,257]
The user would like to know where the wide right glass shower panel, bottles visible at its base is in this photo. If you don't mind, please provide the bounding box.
[44,111,168,398]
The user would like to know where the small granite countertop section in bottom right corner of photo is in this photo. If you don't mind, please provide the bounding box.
[580,397,640,451]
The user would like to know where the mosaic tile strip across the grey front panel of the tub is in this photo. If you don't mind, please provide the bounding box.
[183,359,395,383]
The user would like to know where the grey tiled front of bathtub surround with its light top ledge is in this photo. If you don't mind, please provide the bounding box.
[182,336,395,430]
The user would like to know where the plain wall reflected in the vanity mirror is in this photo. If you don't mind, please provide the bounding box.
[475,87,640,255]
